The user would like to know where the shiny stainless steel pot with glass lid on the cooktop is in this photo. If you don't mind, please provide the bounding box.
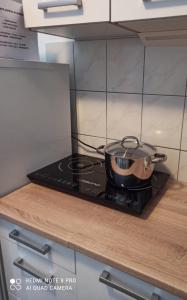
[97,136,167,188]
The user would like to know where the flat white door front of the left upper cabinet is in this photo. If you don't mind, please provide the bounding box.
[23,0,110,28]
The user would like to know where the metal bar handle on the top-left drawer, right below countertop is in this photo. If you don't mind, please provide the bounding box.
[9,229,51,255]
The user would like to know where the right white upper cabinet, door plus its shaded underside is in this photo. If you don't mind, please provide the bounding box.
[111,0,187,32]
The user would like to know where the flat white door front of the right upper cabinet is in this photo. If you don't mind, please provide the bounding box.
[111,0,187,22]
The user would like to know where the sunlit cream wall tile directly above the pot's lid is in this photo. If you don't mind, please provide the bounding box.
[107,93,142,139]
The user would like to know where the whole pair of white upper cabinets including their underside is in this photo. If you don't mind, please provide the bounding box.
[23,0,187,39]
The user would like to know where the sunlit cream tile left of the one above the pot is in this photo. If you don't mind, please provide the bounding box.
[76,91,106,137]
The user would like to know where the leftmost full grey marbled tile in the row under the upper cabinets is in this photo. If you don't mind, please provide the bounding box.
[75,41,106,91]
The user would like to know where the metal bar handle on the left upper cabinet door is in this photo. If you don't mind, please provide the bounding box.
[38,0,82,10]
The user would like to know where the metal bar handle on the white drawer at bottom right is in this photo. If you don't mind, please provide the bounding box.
[99,271,160,300]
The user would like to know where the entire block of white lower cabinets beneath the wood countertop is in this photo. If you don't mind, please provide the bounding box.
[0,220,184,300]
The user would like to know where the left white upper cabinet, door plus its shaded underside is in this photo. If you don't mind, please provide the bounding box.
[23,0,136,39]
